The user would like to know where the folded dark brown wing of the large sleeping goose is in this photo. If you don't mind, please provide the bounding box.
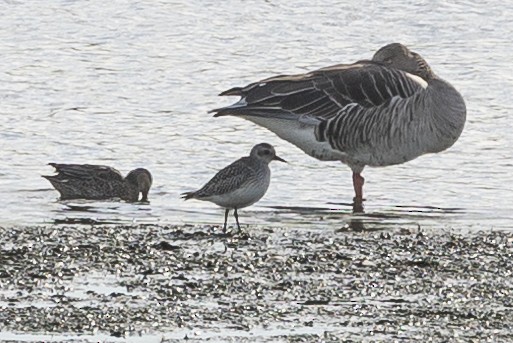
[212,61,427,119]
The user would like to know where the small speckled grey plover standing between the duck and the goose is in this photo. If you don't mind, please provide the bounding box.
[182,143,285,232]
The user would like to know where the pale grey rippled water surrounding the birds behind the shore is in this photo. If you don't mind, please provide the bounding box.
[0,0,513,229]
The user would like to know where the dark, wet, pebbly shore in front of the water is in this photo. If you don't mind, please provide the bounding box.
[0,225,513,342]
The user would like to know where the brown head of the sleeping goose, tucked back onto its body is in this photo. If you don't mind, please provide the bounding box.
[372,43,434,81]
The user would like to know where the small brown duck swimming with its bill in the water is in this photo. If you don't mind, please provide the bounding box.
[43,163,153,202]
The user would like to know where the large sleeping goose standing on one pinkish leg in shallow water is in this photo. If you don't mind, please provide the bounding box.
[212,43,466,210]
